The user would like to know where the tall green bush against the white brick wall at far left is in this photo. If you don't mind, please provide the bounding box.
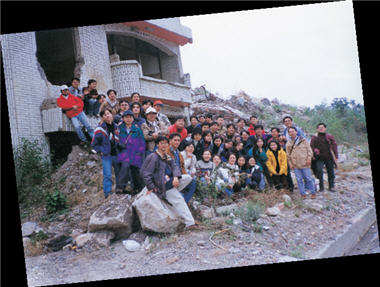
[14,138,50,203]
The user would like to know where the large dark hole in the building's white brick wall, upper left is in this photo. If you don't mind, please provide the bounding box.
[36,28,76,85]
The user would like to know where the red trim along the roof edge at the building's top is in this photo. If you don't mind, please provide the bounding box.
[124,21,193,46]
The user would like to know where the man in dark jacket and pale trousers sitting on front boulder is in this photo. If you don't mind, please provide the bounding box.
[140,136,199,230]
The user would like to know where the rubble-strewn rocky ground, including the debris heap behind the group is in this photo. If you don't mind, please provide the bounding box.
[22,93,378,286]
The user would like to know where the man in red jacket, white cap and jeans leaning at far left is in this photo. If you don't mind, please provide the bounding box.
[57,85,94,146]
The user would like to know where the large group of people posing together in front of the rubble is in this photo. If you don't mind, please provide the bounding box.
[57,78,338,230]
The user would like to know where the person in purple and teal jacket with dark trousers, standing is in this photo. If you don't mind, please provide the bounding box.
[116,110,146,196]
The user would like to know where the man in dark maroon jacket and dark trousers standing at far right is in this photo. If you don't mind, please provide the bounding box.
[310,123,338,192]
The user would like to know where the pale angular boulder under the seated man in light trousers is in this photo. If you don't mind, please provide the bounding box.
[132,188,185,233]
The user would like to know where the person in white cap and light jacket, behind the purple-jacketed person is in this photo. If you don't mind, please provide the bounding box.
[141,107,168,156]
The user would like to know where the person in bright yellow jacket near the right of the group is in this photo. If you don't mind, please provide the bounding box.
[266,141,288,189]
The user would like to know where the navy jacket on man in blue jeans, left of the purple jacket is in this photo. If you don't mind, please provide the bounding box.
[91,122,119,156]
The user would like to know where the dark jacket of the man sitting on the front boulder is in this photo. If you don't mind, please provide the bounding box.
[140,151,181,199]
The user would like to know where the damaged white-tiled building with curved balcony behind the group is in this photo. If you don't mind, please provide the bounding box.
[0,18,192,158]
